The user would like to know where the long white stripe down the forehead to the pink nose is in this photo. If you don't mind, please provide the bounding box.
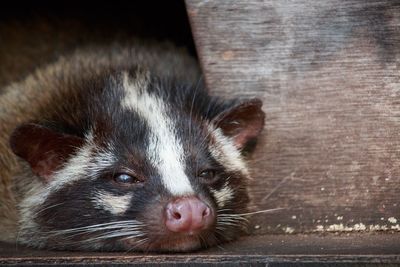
[122,74,193,196]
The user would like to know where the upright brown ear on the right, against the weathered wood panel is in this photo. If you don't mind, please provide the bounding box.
[213,99,265,151]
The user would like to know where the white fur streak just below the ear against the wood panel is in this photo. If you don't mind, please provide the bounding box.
[208,126,249,176]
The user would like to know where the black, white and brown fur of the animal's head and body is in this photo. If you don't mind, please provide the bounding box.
[0,40,264,251]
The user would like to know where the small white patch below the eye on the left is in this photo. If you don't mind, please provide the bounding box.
[92,191,132,215]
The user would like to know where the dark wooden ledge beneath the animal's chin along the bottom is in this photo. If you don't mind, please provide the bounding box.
[0,234,400,266]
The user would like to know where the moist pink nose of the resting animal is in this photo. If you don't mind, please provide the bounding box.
[165,197,214,233]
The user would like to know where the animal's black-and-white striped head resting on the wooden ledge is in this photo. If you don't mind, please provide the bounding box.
[10,71,264,251]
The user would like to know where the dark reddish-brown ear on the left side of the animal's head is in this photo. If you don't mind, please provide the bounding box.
[10,123,84,182]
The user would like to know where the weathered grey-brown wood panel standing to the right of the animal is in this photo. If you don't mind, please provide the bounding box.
[186,0,400,234]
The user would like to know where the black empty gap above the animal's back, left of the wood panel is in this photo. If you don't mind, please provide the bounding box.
[0,1,196,55]
